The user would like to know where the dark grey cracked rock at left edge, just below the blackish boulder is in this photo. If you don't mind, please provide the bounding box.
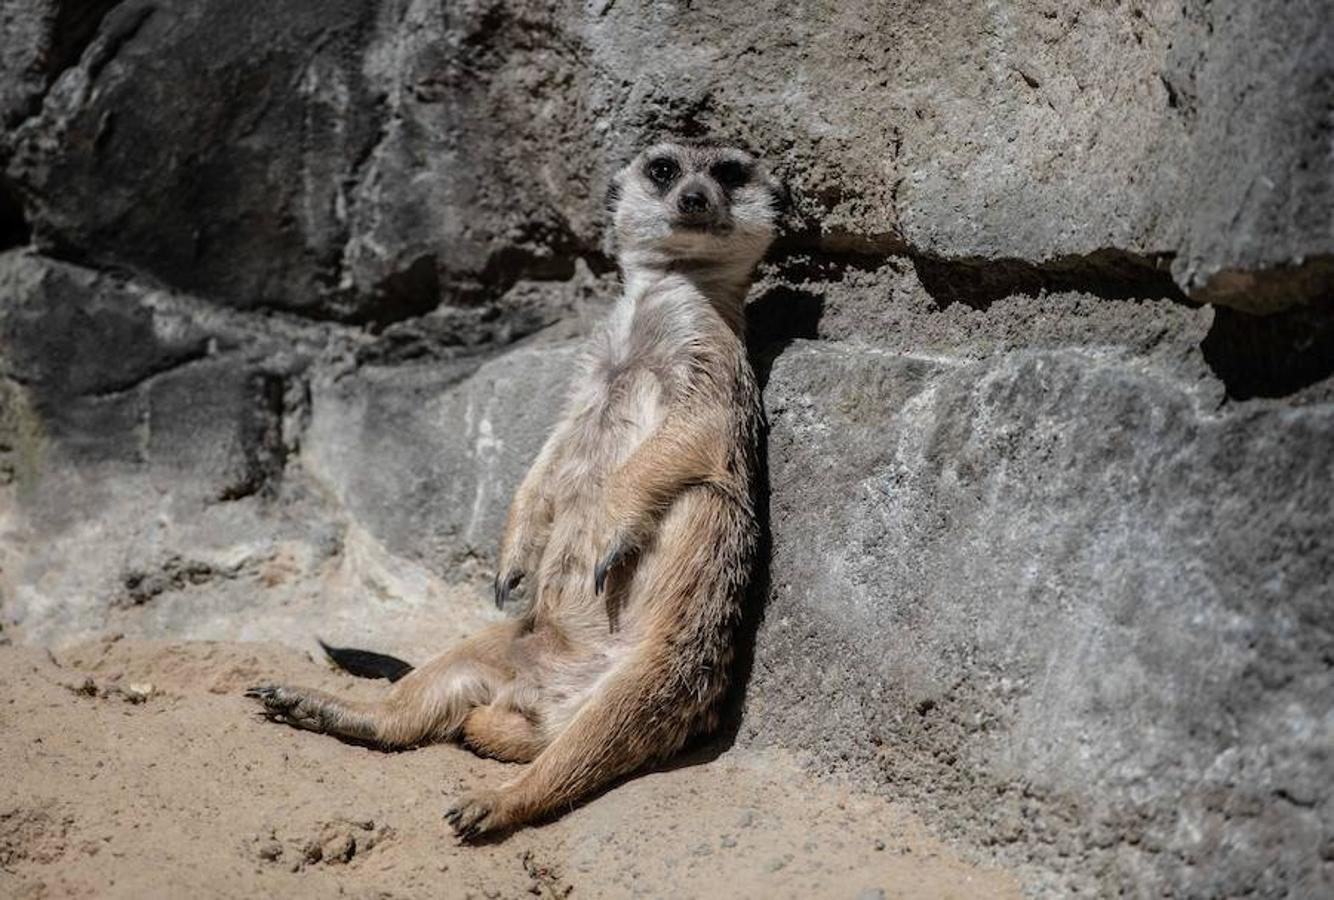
[0,246,304,499]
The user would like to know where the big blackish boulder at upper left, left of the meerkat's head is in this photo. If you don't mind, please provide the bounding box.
[9,0,605,325]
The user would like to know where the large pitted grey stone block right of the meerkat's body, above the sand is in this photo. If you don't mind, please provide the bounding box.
[748,341,1334,891]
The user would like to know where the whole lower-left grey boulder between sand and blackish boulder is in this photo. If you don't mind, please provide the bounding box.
[0,251,594,649]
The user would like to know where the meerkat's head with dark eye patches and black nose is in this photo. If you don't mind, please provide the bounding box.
[607,143,786,268]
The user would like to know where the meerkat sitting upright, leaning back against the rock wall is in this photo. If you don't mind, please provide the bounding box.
[247,143,784,840]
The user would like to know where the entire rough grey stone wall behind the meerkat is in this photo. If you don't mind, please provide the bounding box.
[0,0,1334,896]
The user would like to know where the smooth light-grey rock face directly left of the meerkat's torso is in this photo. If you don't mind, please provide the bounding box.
[303,345,575,571]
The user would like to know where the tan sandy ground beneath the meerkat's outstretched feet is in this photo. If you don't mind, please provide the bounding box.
[0,639,1019,900]
